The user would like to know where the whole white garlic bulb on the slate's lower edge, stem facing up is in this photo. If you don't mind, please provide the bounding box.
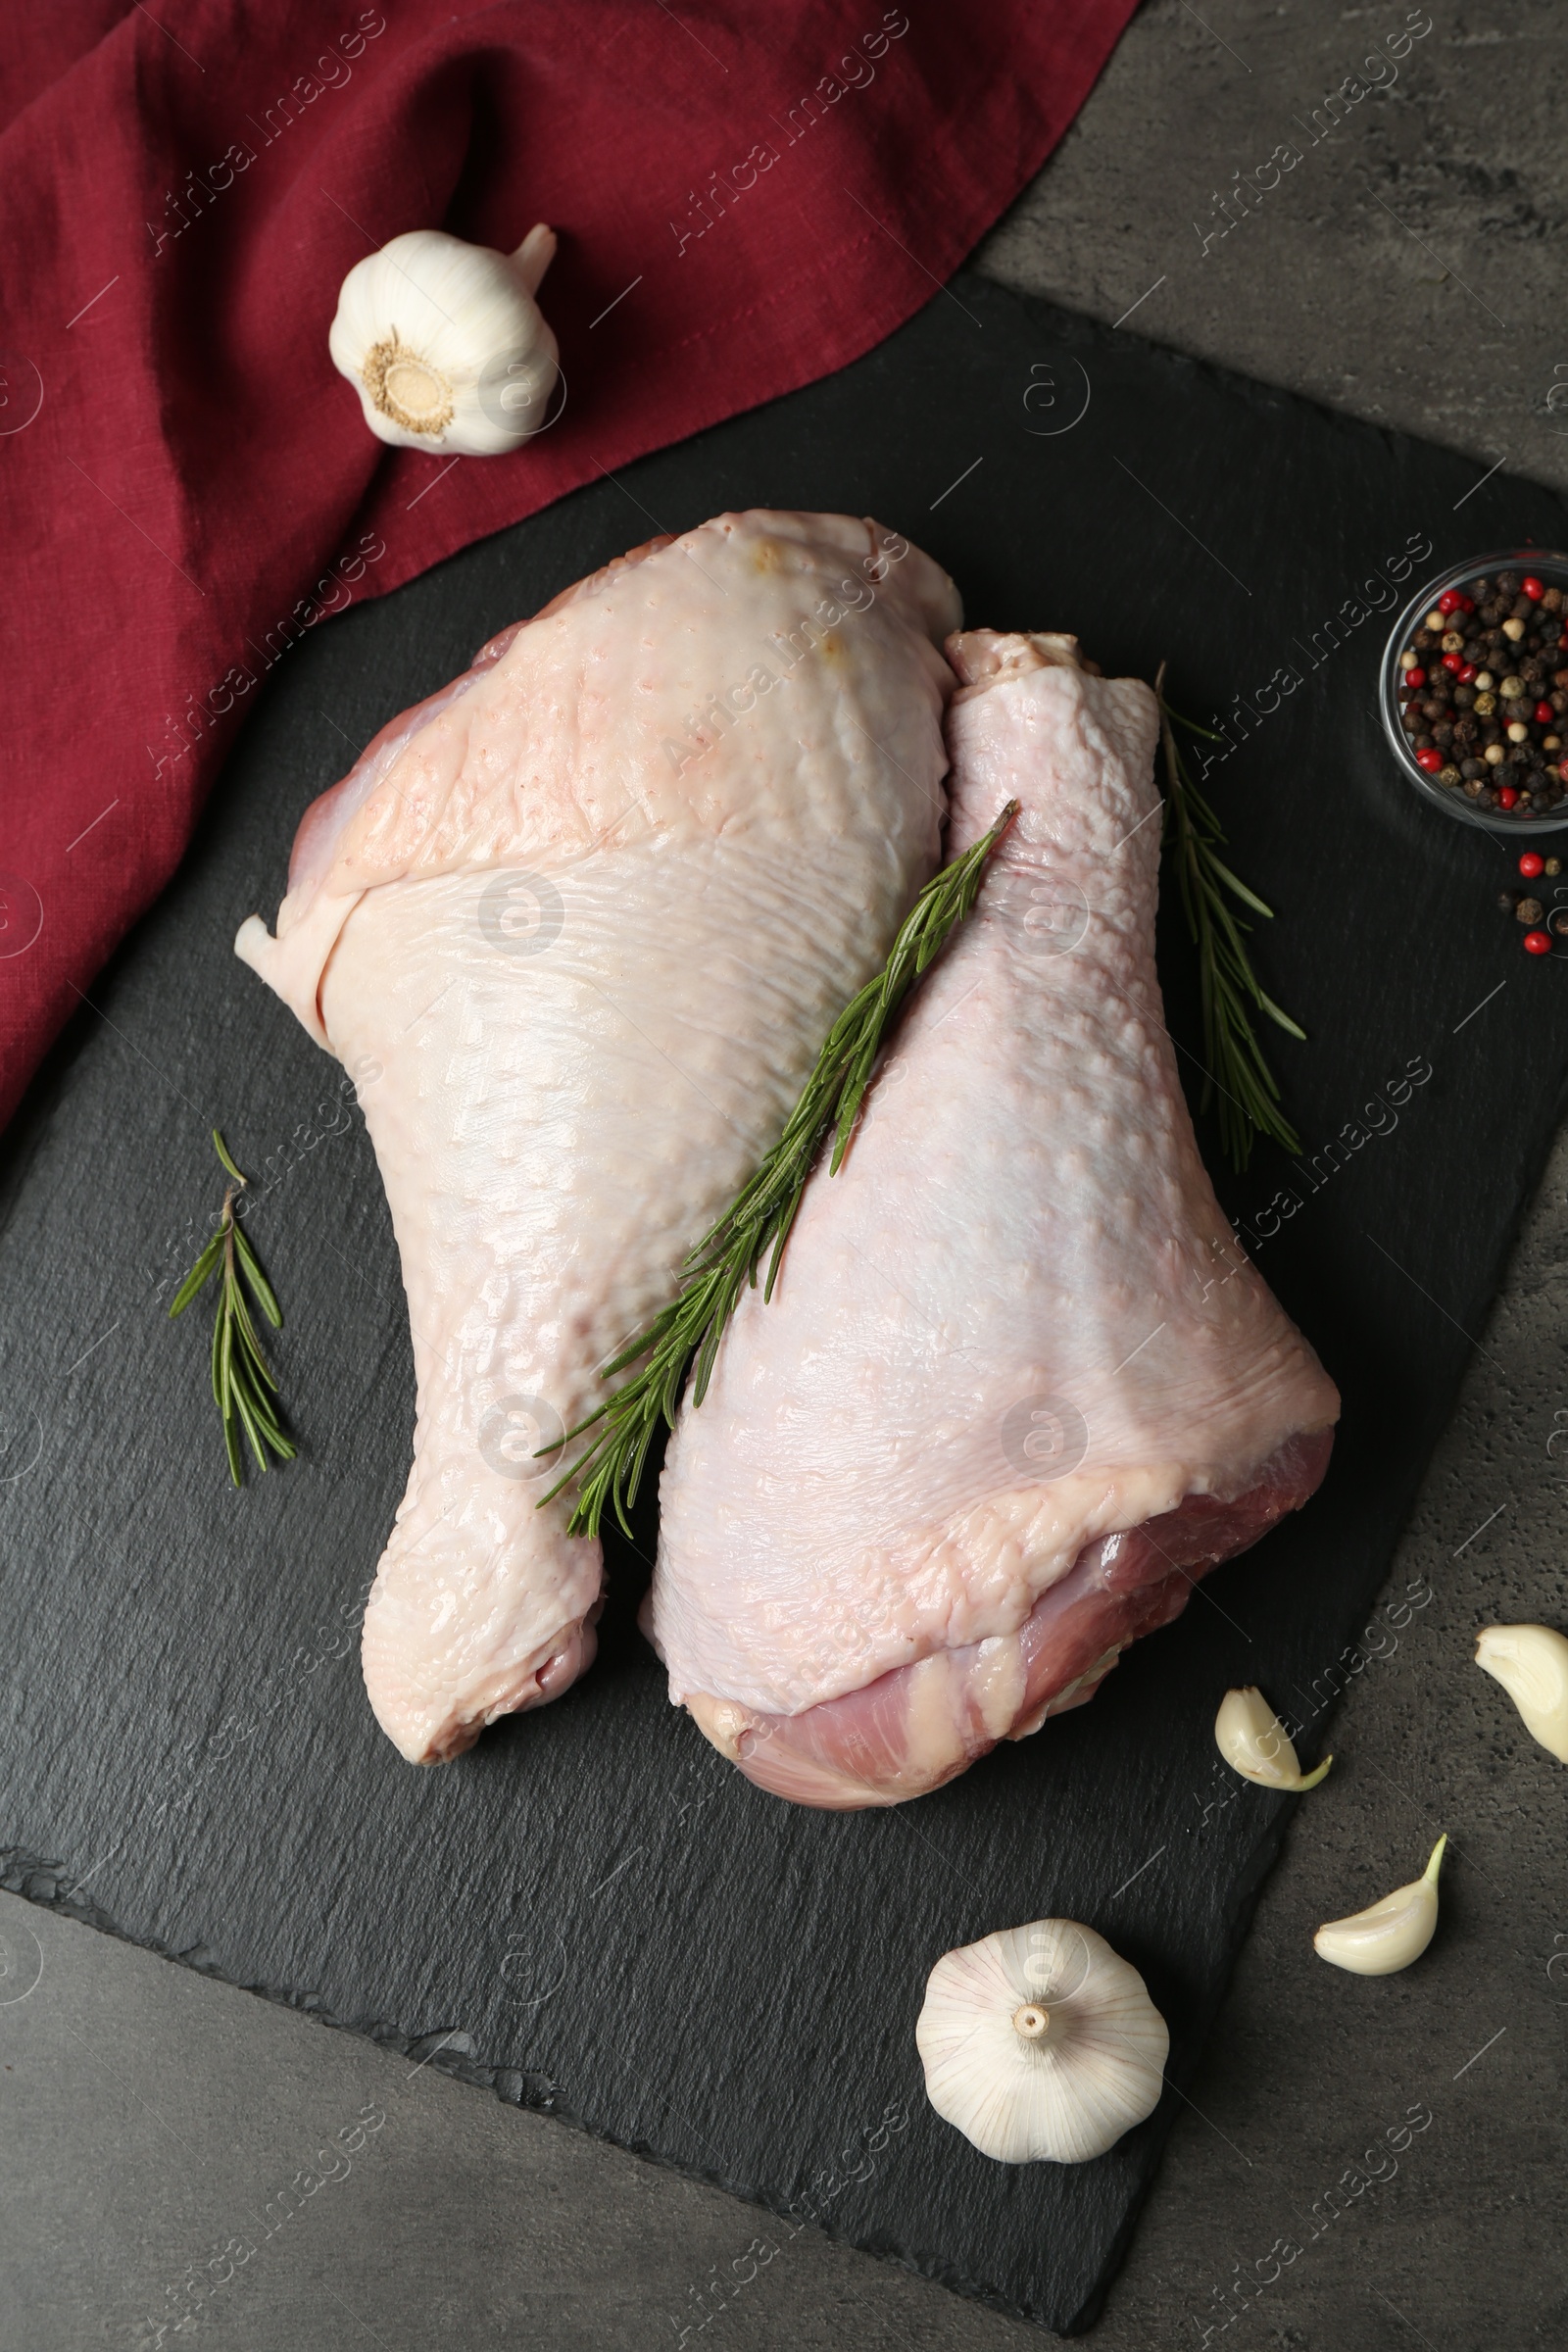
[914,1919,1171,2164]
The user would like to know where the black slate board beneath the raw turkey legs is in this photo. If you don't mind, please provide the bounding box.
[0,277,1568,2333]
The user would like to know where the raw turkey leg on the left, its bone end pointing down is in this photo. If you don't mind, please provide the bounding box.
[235,513,959,1762]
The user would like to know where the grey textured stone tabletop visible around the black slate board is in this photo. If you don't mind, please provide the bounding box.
[0,0,1568,2352]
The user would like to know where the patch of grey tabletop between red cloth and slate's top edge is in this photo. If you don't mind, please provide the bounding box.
[978,0,1568,487]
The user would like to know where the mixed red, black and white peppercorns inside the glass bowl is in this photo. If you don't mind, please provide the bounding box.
[1398,571,1568,818]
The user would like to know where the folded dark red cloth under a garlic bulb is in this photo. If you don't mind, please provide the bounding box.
[0,0,1133,1122]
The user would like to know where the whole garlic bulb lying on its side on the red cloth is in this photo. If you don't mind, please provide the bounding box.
[326,223,558,457]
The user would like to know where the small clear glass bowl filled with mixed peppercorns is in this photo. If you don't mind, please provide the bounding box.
[1382,548,1568,833]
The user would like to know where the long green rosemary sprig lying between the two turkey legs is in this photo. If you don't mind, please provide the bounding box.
[541,800,1018,1536]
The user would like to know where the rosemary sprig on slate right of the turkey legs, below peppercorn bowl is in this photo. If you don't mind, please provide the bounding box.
[1154,661,1307,1174]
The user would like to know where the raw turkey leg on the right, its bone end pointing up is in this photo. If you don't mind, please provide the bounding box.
[644,630,1340,1809]
